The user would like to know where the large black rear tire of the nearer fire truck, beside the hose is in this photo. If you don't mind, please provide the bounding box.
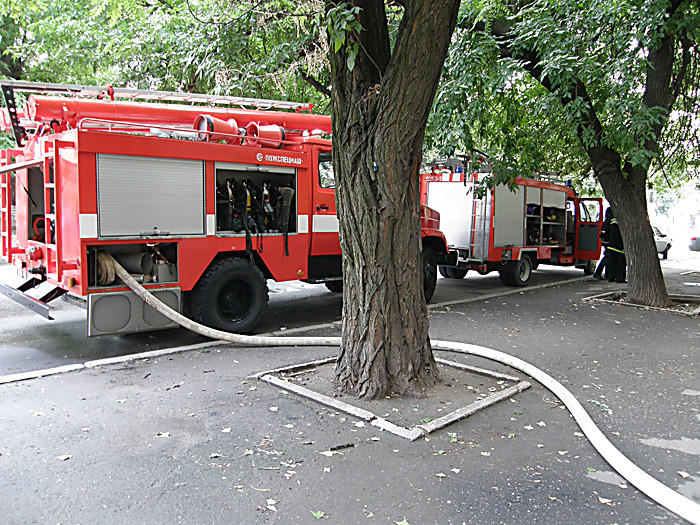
[190,258,268,333]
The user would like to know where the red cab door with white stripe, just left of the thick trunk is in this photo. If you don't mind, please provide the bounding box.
[309,148,341,278]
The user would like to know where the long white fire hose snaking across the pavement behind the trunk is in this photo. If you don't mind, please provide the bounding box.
[113,253,700,525]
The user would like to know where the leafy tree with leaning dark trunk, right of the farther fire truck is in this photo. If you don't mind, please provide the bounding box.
[430,0,700,306]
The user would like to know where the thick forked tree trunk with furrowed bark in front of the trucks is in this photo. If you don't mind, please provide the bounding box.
[330,0,459,398]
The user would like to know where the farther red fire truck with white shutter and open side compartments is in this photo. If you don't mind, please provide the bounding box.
[421,157,603,286]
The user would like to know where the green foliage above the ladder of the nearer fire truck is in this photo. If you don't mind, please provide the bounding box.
[0,0,328,105]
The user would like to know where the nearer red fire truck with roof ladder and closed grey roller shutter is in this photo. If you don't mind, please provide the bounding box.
[0,81,448,336]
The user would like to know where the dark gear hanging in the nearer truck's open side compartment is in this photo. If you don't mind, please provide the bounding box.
[216,169,297,235]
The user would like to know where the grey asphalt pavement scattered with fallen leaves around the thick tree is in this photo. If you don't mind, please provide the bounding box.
[0,256,700,525]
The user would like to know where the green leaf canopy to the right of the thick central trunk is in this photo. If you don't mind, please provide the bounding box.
[428,0,700,192]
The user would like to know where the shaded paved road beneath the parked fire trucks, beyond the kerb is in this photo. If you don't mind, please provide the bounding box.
[0,249,700,376]
